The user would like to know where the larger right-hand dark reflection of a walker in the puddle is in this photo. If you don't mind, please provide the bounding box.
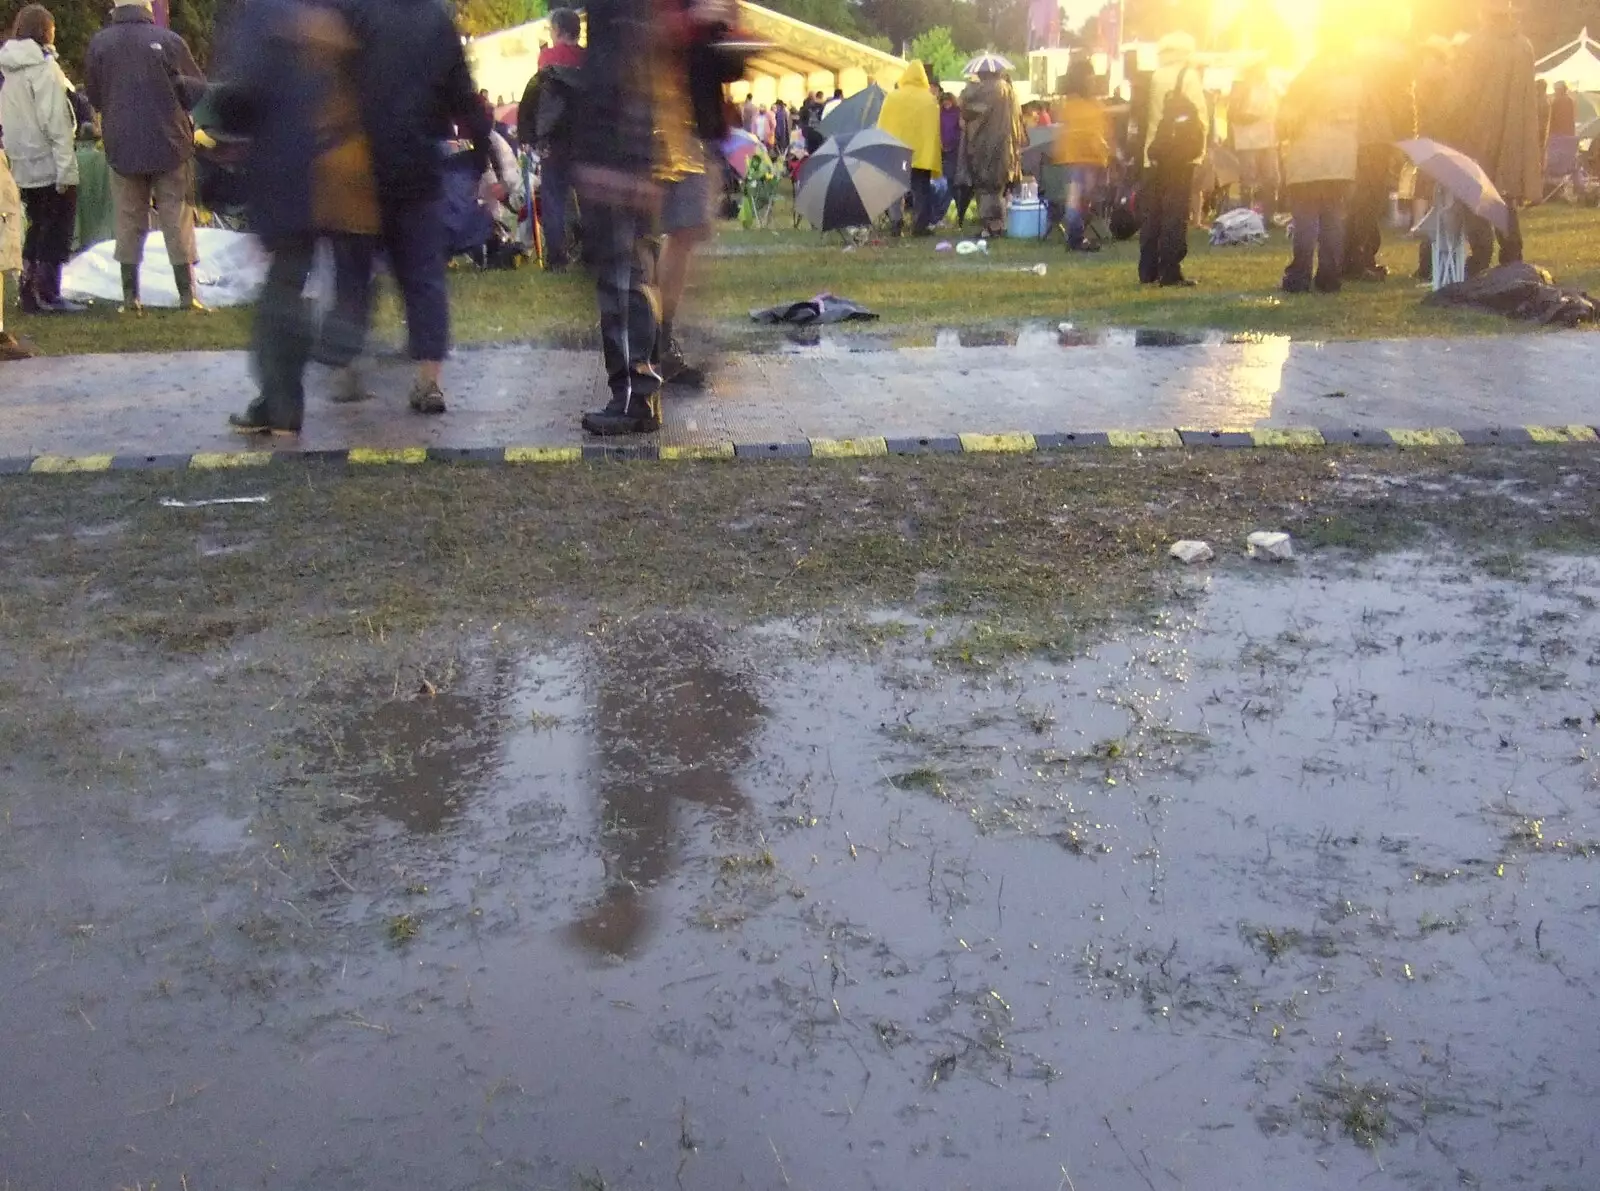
[571,623,763,956]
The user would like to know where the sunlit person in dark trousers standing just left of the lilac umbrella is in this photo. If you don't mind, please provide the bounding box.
[1344,42,1416,282]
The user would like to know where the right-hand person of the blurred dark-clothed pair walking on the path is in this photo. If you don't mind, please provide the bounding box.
[331,0,492,415]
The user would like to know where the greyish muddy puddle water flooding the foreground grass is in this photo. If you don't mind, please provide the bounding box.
[0,559,1600,1191]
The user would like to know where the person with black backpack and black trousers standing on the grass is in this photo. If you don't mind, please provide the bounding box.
[1139,34,1210,287]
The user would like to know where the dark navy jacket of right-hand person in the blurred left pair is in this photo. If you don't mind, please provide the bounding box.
[341,0,493,207]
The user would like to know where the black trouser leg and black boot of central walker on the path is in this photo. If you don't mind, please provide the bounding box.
[582,207,661,435]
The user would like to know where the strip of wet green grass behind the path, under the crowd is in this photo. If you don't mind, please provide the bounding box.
[18,207,1600,355]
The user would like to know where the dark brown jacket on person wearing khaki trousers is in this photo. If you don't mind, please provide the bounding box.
[83,5,205,176]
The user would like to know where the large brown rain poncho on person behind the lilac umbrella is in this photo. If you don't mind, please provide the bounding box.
[1450,19,1544,202]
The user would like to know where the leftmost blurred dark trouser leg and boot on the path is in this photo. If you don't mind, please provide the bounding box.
[229,235,315,432]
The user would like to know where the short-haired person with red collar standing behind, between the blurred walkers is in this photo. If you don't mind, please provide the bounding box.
[517,8,584,272]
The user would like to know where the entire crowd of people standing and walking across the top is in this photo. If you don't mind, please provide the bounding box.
[0,0,1576,435]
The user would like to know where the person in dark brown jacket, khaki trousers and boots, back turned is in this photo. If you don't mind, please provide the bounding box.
[83,0,205,314]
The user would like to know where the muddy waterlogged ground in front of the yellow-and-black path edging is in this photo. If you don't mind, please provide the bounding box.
[0,448,1600,1191]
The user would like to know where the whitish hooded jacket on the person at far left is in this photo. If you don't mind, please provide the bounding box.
[0,38,78,190]
